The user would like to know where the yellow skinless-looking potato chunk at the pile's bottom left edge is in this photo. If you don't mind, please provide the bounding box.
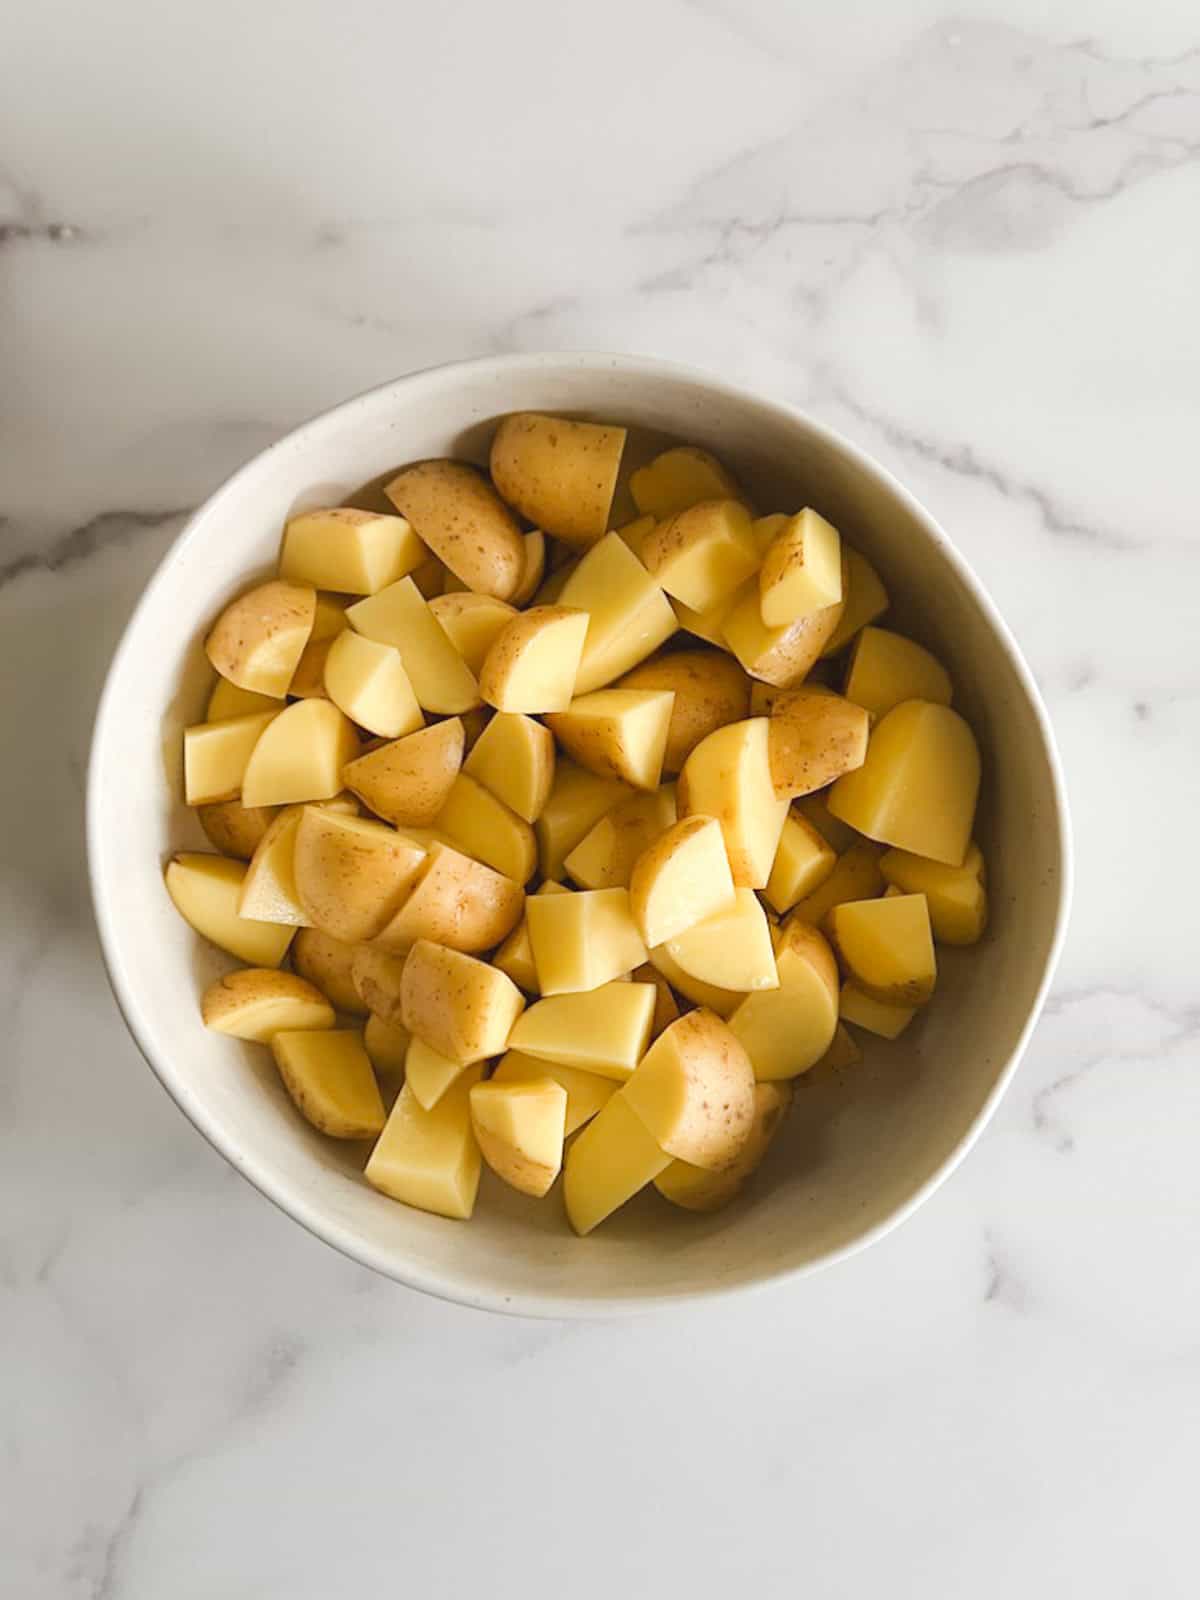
[363,1067,482,1221]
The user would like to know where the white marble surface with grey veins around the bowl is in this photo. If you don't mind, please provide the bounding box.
[0,0,1200,1600]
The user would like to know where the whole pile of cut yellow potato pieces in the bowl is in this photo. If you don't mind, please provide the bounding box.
[166,414,986,1234]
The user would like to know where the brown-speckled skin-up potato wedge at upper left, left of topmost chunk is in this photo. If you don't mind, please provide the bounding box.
[384,461,525,600]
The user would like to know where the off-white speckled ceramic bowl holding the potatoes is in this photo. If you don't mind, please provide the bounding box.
[88,355,1070,1317]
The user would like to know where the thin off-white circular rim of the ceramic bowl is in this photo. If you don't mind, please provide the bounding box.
[85,350,1075,1320]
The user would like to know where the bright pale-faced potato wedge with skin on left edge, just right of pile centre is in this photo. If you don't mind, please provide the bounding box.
[629,816,734,949]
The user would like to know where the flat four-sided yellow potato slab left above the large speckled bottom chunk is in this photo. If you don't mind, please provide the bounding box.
[509,982,656,1080]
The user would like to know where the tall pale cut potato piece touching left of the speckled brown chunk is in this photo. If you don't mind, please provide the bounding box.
[680,717,787,890]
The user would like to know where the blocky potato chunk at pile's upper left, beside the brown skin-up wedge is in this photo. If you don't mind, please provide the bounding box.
[278,506,429,595]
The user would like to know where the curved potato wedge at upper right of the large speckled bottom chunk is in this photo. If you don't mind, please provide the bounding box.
[730,922,838,1083]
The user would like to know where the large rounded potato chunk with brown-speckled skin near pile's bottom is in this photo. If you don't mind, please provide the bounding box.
[621,1011,754,1176]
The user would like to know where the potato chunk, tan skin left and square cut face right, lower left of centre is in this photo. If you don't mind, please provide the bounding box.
[400,940,533,1062]
